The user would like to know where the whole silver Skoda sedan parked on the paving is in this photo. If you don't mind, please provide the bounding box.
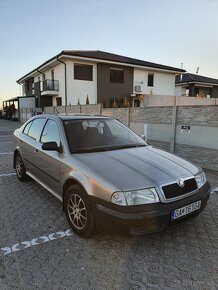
[14,115,211,237]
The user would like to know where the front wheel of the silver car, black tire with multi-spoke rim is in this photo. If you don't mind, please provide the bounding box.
[64,184,95,238]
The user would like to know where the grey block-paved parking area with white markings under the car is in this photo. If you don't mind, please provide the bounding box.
[0,120,218,290]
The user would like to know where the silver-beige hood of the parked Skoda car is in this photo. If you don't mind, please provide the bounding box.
[74,146,199,191]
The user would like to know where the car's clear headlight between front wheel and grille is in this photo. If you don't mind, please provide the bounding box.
[111,188,160,205]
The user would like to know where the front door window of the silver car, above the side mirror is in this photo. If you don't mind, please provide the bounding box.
[41,120,61,146]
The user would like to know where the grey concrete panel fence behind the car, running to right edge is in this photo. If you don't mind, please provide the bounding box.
[45,104,218,171]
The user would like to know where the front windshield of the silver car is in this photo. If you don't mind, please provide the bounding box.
[63,118,147,153]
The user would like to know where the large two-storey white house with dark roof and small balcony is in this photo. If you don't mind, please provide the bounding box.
[17,50,185,107]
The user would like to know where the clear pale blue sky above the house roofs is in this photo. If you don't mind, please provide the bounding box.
[0,0,218,107]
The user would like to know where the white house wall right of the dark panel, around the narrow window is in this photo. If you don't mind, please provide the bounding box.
[133,69,175,96]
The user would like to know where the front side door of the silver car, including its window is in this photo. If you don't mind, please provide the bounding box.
[35,119,63,193]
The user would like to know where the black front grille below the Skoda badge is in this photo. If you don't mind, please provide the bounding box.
[162,178,197,199]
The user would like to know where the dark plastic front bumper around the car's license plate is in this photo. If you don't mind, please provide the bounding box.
[89,182,211,235]
